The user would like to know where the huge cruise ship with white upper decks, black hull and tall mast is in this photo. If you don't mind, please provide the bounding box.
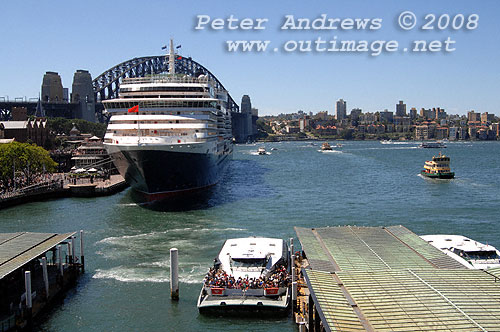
[103,41,233,201]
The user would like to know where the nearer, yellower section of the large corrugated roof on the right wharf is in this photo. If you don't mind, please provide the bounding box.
[305,268,500,332]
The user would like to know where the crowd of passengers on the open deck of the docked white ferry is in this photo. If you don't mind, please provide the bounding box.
[204,265,290,290]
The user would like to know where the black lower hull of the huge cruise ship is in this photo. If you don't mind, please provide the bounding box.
[111,149,231,202]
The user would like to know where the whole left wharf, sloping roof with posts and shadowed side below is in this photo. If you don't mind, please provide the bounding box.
[0,231,85,332]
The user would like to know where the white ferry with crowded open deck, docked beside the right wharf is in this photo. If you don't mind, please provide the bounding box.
[198,237,291,314]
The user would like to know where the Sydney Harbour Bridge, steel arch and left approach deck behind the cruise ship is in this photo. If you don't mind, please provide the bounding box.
[0,55,240,121]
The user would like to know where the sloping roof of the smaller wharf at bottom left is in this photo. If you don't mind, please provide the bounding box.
[0,232,75,279]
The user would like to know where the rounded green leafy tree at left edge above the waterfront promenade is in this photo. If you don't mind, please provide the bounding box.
[0,142,57,185]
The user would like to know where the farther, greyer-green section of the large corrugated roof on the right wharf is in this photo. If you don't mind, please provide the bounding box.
[296,226,465,272]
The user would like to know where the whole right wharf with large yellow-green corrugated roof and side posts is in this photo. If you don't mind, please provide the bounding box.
[294,226,500,332]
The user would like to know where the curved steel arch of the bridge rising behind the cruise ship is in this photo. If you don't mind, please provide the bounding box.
[92,55,240,112]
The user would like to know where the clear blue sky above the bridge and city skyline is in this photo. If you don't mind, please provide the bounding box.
[0,0,500,115]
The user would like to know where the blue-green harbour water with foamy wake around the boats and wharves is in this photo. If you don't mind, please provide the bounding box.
[0,141,500,332]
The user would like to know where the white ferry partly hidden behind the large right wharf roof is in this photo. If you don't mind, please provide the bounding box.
[420,235,500,269]
